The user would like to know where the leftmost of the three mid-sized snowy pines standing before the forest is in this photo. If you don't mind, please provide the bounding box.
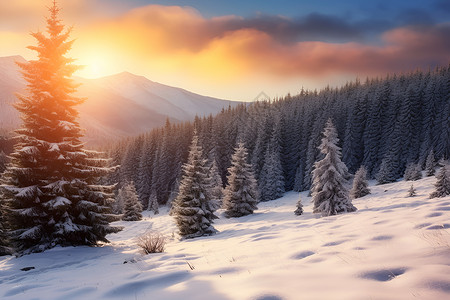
[174,133,217,238]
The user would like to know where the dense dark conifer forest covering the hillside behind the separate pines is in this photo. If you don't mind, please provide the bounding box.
[107,67,450,206]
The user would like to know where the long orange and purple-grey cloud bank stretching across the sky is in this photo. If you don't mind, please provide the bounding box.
[77,5,450,76]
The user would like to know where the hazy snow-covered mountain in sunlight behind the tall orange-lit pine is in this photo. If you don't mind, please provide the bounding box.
[0,56,239,143]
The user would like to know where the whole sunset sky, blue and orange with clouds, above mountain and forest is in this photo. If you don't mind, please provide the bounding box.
[0,0,450,101]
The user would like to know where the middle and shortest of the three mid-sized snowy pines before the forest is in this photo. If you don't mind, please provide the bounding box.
[223,143,258,218]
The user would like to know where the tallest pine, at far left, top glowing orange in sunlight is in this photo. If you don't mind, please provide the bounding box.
[2,1,120,253]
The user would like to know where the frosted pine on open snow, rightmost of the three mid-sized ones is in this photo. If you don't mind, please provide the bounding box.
[312,119,356,216]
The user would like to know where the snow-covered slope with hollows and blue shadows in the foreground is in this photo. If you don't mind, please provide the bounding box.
[0,177,450,300]
